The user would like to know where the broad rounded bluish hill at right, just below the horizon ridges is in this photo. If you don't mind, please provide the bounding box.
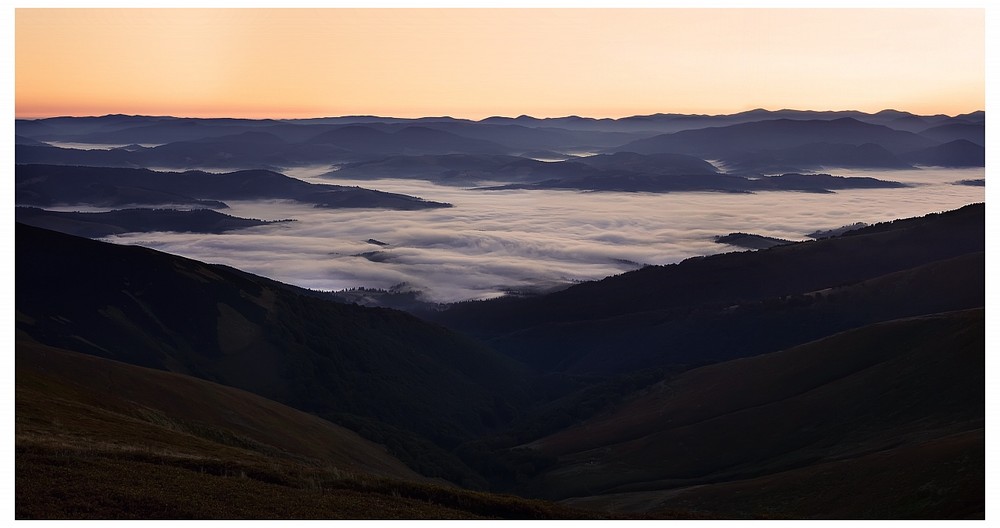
[615,118,935,159]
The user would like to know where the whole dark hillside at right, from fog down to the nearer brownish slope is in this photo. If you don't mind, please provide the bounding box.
[426,204,985,375]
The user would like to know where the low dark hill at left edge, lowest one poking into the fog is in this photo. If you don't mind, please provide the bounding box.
[14,207,288,238]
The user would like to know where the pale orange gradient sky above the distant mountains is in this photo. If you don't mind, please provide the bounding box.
[14,8,986,119]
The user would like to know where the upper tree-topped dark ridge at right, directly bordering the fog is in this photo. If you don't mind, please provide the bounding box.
[438,204,985,342]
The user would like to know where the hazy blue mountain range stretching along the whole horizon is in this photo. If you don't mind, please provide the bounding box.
[15,109,985,175]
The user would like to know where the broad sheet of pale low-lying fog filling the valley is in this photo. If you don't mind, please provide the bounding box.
[95,167,985,302]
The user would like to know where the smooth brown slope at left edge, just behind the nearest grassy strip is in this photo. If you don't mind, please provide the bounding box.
[16,339,427,481]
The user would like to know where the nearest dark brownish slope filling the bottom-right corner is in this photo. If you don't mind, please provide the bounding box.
[530,309,985,518]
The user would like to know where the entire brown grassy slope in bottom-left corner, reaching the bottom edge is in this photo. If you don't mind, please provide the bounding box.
[15,339,632,519]
